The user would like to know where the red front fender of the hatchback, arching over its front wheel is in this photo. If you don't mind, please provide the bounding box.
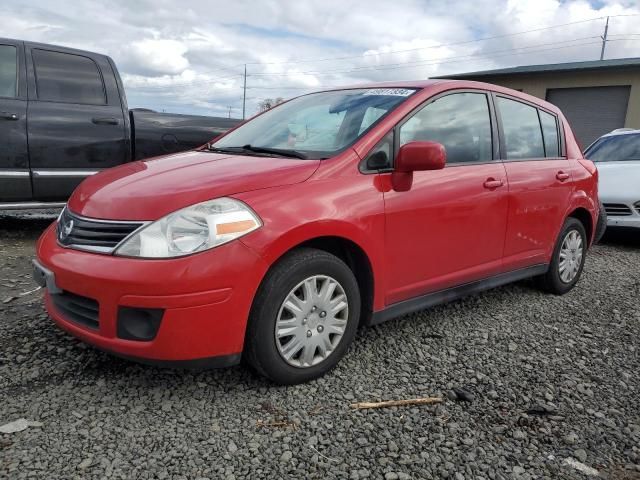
[234,175,384,309]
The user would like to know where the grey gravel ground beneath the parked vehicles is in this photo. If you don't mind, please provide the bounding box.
[0,212,640,480]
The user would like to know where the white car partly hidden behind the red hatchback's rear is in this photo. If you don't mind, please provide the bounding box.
[584,128,640,228]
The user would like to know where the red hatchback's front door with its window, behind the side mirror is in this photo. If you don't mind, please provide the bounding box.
[384,91,508,305]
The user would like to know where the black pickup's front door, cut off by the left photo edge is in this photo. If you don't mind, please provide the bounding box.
[0,39,31,204]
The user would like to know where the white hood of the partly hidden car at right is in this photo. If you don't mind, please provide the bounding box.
[596,161,640,202]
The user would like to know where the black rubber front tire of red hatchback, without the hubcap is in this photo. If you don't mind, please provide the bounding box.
[243,248,360,385]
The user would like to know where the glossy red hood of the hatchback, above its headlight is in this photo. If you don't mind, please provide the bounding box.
[68,151,320,220]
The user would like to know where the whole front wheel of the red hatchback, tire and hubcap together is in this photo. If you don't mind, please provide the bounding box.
[244,248,360,385]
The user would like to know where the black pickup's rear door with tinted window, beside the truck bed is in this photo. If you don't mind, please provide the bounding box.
[25,44,130,201]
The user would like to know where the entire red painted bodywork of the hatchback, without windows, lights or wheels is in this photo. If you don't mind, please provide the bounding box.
[37,81,598,360]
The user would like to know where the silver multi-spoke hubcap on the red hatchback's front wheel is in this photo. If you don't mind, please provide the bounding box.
[275,275,349,368]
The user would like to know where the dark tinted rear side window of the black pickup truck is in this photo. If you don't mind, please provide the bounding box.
[31,49,107,105]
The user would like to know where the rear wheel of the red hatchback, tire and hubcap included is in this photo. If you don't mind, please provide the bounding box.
[537,217,588,295]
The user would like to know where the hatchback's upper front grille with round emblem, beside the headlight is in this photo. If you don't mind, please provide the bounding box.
[57,208,144,253]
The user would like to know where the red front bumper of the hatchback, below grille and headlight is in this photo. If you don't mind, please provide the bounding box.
[36,226,267,366]
